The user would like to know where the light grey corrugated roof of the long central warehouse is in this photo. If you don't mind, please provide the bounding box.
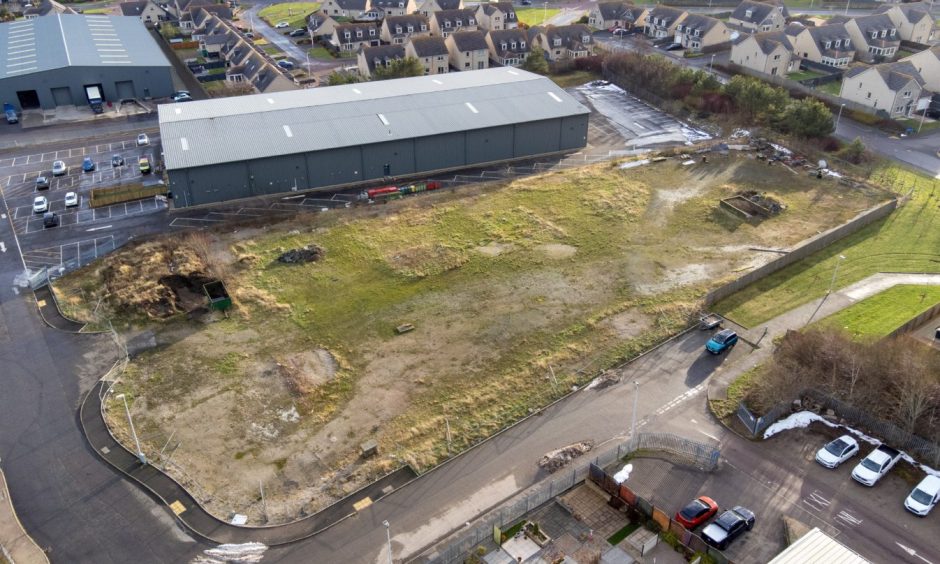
[158,67,588,169]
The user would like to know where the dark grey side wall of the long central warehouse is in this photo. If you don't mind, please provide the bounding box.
[167,115,588,207]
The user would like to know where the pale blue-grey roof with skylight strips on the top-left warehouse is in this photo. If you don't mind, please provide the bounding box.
[0,14,170,78]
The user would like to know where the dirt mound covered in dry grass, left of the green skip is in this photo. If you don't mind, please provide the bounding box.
[102,241,211,318]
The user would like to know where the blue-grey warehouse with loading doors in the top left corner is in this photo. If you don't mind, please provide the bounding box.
[0,14,173,110]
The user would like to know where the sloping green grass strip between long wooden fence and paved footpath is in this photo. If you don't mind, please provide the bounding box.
[715,166,940,327]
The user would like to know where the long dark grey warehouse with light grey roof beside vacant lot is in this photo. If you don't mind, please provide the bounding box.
[159,67,589,207]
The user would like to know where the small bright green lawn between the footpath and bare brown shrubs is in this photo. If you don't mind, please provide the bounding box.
[819,285,940,337]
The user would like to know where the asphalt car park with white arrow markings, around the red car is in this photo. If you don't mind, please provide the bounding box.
[627,426,940,564]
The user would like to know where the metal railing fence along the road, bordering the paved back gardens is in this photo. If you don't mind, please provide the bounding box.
[418,433,719,564]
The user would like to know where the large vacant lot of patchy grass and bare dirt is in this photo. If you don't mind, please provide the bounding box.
[58,156,883,522]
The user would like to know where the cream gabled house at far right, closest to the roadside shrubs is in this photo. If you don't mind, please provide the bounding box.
[839,61,929,118]
